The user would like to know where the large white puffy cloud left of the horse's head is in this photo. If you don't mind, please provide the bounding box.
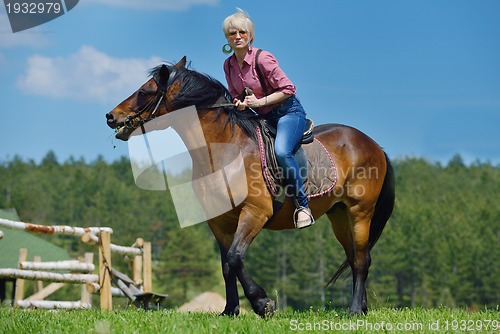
[17,46,160,102]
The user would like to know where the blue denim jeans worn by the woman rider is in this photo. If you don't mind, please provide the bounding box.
[266,96,309,208]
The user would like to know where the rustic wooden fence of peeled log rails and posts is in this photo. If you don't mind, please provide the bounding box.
[0,218,154,310]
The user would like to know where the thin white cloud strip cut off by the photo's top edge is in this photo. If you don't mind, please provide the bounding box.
[84,0,219,10]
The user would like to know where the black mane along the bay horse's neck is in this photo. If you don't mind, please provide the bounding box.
[149,64,259,139]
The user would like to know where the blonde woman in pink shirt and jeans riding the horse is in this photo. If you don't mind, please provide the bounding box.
[222,9,314,228]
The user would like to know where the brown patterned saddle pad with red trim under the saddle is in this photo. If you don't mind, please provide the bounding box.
[257,128,337,198]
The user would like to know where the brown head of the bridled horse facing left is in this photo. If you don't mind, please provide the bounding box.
[106,56,186,141]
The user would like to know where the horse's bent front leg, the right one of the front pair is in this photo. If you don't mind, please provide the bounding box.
[227,207,274,317]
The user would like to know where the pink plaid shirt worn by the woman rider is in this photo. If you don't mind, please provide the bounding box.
[224,47,296,115]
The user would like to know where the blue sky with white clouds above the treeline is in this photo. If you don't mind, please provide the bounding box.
[0,0,500,165]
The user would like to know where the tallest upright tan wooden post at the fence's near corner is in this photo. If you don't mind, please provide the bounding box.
[99,231,113,310]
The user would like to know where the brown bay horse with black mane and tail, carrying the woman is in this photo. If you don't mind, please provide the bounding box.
[106,57,395,317]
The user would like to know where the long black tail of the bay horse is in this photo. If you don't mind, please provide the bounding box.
[326,152,396,286]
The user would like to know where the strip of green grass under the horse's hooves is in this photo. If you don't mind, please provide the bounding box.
[0,307,500,334]
